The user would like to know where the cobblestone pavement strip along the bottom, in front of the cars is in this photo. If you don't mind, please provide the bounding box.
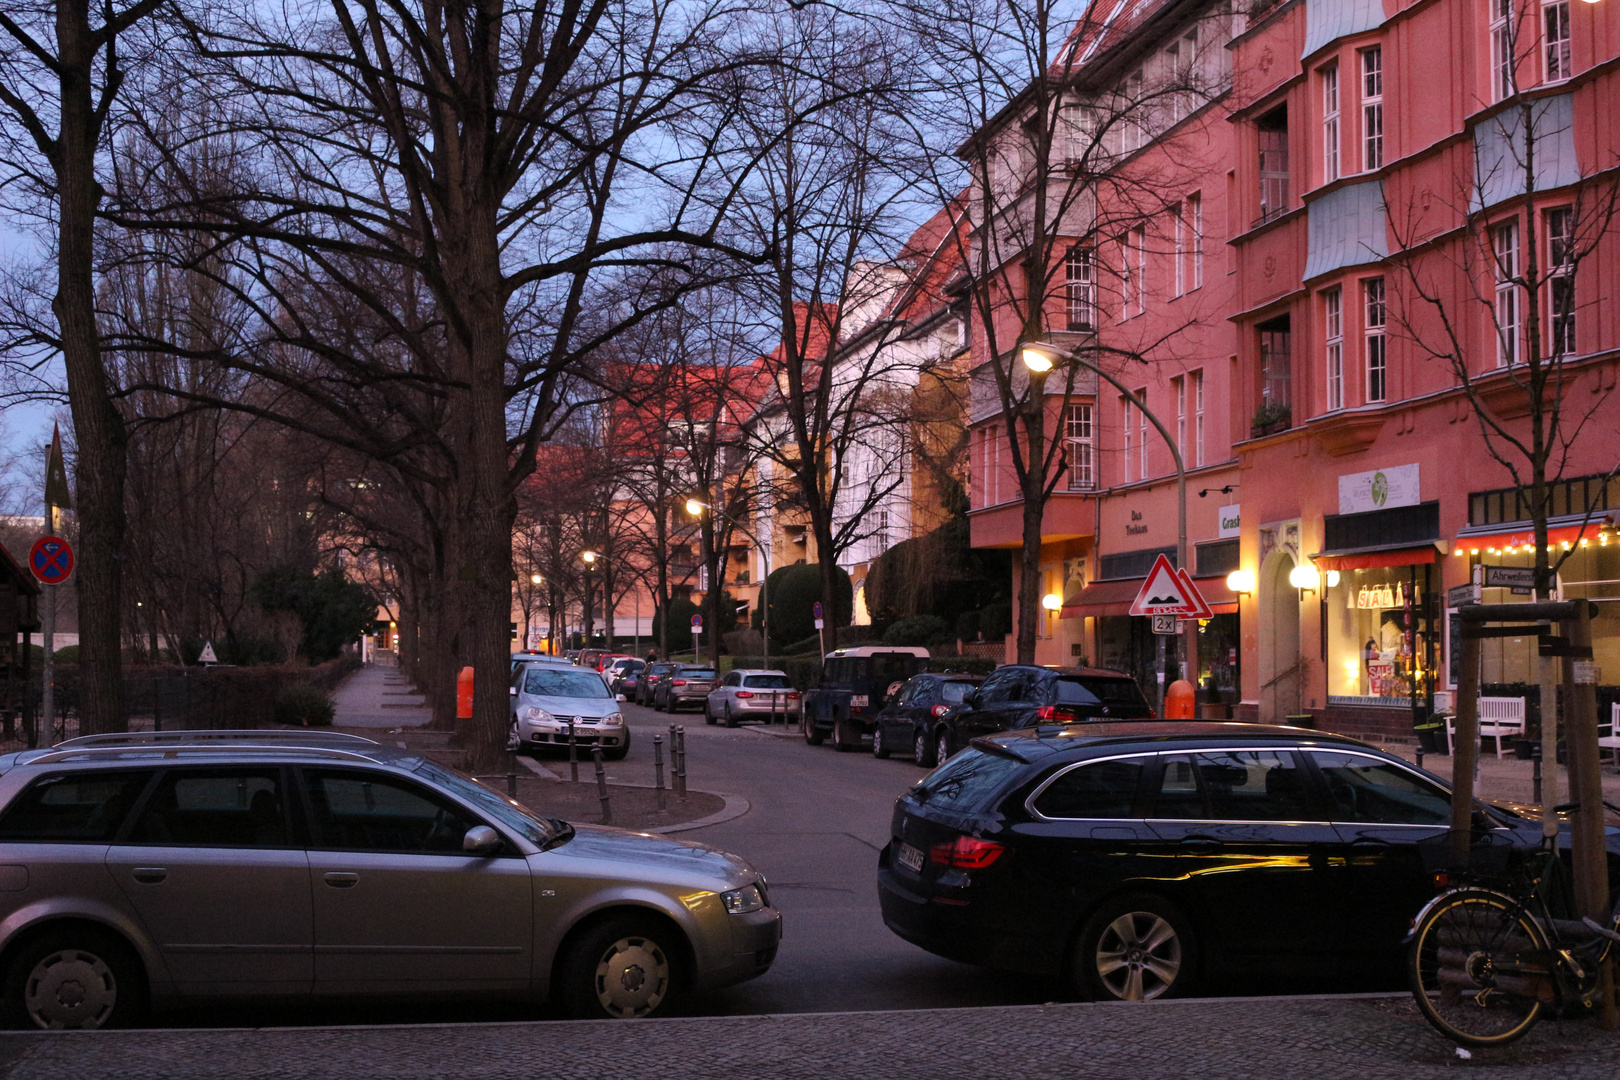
[0,996,1620,1080]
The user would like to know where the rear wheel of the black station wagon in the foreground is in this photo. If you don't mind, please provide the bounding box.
[1071,895,1197,1001]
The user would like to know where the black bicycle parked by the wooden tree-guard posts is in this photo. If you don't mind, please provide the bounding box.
[1408,801,1620,1048]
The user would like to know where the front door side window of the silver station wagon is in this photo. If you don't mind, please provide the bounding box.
[305,769,483,855]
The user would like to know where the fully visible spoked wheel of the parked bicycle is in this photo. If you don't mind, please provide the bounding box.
[1408,891,1554,1046]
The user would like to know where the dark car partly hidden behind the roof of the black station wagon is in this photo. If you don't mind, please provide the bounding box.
[956,664,1153,732]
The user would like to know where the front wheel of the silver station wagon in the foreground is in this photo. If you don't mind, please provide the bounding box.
[559,915,680,1020]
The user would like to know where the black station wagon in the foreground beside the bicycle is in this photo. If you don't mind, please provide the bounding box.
[878,721,1620,999]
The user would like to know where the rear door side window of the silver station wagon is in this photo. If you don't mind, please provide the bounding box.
[126,767,293,847]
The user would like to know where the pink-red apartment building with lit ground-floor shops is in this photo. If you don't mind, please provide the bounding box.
[974,0,1620,744]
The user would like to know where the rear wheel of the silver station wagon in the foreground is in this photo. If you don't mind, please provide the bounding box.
[5,929,146,1030]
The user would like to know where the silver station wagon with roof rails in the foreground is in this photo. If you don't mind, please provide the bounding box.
[0,725,781,1028]
